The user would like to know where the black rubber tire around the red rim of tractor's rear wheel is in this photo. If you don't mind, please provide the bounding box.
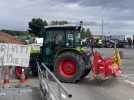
[54,52,85,83]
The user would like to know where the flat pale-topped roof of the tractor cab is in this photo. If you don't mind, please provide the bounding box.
[45,25,81,31]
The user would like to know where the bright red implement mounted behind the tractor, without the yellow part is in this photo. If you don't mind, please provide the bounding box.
[92,51,121,79]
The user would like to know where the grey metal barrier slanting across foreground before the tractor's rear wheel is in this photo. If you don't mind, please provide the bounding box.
[37,62,72,100]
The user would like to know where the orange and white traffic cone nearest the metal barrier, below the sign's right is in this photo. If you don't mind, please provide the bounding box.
[19,68,28,87]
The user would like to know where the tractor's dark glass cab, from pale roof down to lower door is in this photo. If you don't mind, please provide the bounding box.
[43,25,81,64]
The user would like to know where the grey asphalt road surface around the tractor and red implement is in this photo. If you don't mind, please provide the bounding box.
[0,48,134,100]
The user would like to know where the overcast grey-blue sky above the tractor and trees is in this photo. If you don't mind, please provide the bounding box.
[0,0,134,35]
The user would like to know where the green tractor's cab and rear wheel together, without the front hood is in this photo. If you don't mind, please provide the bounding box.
[41,25,91,83]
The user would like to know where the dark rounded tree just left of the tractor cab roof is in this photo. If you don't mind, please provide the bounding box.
[28,18,48,37]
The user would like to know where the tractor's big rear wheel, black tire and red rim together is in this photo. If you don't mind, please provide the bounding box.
[54,52,85,83]
